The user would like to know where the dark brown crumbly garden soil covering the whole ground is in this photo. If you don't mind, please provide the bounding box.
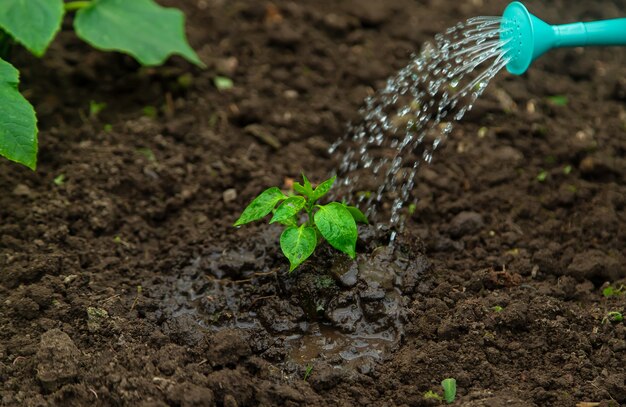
[0,0,626,406]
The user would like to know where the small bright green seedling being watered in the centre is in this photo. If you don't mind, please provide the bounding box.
[234,174,368,272]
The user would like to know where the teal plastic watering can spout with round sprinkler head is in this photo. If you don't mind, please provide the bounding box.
[500,1,626,75]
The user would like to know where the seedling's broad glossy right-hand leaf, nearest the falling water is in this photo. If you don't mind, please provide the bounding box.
[314,202,358,258]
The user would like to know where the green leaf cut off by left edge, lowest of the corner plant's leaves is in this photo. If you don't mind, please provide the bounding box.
[0,59,37,170]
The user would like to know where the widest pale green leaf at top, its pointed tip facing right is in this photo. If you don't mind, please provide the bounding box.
[74,0,204,66]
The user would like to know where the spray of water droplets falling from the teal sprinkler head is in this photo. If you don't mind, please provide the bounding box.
[330,17,510,237]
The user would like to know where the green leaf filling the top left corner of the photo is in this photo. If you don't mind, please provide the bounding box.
[0,0,64,56]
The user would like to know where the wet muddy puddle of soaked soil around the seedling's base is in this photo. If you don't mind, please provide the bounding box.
[145,231,429,372]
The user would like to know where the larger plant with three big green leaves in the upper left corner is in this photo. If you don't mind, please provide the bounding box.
[0,0,204,170]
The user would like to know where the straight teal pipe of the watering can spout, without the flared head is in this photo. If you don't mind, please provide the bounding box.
[552,18,626,48]
